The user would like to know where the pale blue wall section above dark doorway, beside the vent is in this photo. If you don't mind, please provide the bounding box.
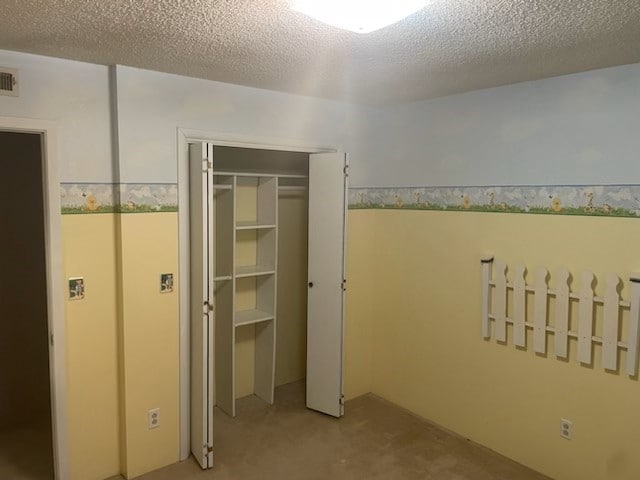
[0,50,113,182]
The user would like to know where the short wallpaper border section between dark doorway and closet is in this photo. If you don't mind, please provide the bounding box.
[60,183,178,214]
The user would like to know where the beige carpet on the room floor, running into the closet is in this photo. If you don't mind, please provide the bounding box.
[122,383,547,480]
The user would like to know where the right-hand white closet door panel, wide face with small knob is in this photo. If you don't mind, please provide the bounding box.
[307,153,348,417]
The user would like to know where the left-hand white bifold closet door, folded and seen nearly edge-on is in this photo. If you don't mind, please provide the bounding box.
[189,143,214,468]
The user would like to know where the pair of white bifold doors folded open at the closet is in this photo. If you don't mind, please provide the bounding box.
[189,143,347,468]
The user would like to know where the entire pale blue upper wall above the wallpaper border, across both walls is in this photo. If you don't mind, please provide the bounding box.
[0,50,640,186]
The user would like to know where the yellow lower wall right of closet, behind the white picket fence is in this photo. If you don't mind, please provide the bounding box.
[347,210,640,480]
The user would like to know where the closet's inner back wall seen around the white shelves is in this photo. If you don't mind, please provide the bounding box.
[214,147,309,398]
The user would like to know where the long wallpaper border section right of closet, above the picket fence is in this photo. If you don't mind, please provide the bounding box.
[349,185,640,217]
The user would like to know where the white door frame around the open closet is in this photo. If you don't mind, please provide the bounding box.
[177,127,337,461]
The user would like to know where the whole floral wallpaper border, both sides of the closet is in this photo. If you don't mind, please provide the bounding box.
[60,183,640,218]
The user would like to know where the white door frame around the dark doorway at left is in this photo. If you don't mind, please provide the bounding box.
[0,116,69,480]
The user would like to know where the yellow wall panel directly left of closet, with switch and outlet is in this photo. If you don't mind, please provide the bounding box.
[119,213,180,478]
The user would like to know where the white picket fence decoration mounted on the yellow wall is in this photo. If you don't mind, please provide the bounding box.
[481,256,640,377]
